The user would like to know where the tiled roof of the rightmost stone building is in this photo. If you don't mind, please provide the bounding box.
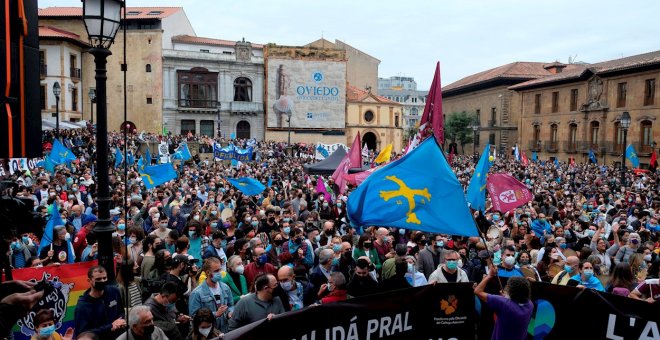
[509,51,660,90]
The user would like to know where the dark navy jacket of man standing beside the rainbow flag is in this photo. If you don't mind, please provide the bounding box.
[74,286,124,339]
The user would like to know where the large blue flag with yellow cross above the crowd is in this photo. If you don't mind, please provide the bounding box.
[347,138,478,236]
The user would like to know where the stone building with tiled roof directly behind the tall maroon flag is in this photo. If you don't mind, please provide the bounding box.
[442,62,573,154]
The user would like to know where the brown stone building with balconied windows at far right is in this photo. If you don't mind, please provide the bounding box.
[509,51,660,167]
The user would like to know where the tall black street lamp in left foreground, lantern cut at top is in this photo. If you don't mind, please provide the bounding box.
[83,0,124,281]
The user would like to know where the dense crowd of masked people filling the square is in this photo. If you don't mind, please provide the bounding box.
[1,130,660,340]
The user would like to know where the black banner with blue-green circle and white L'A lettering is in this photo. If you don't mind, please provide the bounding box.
[528,283,660,340]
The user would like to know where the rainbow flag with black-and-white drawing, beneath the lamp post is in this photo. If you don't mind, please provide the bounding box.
[12,261,98,340]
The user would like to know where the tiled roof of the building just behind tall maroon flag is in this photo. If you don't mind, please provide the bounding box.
[442,61,552,95]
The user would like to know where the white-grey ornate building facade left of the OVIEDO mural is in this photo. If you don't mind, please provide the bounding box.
[163,35,265,140]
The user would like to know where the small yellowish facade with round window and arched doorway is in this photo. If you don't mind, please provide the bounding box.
[344,85,403,152]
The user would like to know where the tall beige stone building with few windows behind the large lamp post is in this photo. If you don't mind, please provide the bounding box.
[39,7,195,132]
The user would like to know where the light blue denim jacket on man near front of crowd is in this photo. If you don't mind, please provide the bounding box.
[188,281,234,333]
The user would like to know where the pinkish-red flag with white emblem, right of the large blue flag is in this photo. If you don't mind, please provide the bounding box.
[486,174,534,211]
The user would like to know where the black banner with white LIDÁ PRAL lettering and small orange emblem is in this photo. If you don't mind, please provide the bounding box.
[224,283,475,340]
